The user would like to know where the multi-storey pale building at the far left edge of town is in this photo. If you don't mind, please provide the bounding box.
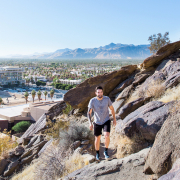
[0,66,25,86]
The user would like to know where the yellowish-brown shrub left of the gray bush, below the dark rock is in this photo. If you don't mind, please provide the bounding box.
[45,119,70,139]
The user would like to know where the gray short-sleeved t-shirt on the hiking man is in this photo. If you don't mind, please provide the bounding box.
[88,96,112,125]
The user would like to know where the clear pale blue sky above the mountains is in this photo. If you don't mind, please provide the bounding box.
[0,0,180,56]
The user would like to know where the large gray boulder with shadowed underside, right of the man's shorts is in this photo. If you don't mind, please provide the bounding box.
[116,101,174,141]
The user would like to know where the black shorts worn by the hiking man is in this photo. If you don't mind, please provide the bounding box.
[94,120,111,136]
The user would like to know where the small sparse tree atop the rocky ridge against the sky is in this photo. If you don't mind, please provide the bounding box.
[148,32,170,53]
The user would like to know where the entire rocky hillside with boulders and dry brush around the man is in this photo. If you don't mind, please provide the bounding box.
[1,41,180,180]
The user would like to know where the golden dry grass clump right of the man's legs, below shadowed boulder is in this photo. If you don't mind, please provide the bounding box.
[113,134,148,158]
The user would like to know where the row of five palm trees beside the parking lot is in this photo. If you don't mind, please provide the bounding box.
[24,89,54,104]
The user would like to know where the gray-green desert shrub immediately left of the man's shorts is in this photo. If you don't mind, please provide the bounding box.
[59,123,94,149]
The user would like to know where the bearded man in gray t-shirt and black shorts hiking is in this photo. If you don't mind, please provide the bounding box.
[87,86,116,161]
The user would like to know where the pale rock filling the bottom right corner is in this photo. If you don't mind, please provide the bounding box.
[158,158,180,180]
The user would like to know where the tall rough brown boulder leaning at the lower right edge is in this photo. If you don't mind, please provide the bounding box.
[144,106,180,175]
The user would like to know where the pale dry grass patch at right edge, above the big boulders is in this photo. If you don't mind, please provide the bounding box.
[158,85,180,103]
